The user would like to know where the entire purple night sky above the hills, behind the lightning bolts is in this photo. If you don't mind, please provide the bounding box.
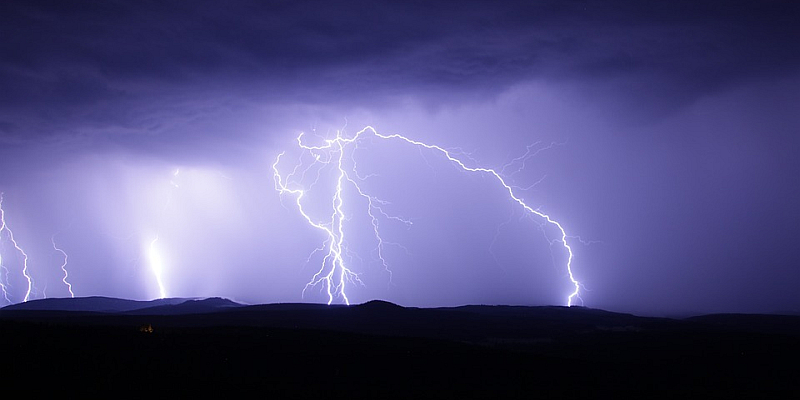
[0,0,800,315]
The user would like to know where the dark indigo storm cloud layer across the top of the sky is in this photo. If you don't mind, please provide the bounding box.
[0,1,800,141]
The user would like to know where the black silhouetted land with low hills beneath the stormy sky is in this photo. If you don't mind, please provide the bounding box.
[0,297,800,399]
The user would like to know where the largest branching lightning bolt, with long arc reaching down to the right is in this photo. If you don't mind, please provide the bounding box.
[272,126,581,306]
